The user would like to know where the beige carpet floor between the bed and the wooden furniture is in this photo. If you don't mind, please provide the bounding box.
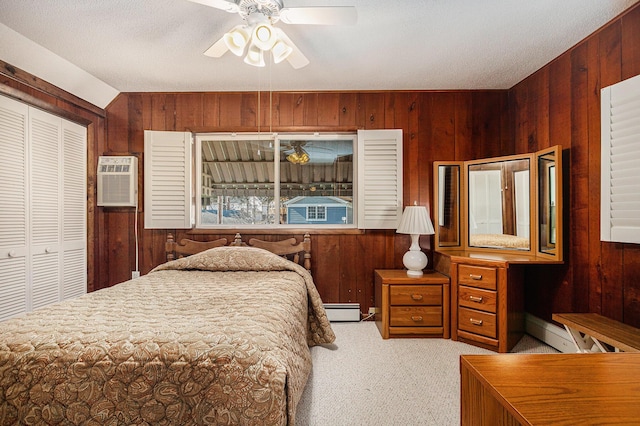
[296,322,557,426]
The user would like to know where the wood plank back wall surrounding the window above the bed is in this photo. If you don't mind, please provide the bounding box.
[104,91,513,312]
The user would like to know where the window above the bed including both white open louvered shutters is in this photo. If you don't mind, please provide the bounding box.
[144,129,402,229]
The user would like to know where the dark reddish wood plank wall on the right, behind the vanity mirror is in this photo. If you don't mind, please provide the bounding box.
[509,5,640,327]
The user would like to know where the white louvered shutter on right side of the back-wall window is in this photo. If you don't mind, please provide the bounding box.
[357,129,402,229]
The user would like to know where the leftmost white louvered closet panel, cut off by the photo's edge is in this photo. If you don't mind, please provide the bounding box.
[0,96,28,321]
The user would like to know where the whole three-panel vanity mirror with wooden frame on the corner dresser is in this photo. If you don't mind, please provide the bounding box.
[434,146,562,261]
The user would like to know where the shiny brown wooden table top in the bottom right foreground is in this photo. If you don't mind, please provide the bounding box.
[460,353,640,425]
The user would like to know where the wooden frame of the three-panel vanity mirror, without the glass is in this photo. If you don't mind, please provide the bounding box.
[433,145,564,262]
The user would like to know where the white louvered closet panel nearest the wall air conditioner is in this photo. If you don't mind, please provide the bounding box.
[61,120,87,300]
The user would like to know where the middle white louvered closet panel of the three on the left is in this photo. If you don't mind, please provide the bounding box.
[29,109,62,309]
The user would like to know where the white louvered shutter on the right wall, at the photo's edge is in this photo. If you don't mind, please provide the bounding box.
[600,75,640,244]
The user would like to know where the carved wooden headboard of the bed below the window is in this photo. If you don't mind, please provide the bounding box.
[165,233,311,271]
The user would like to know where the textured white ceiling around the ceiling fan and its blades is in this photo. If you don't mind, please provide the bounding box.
[0,0,638,106]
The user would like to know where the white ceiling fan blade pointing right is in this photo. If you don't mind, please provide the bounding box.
[280,6,358,25]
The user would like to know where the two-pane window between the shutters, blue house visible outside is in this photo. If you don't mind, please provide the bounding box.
[196,134,356,227]
